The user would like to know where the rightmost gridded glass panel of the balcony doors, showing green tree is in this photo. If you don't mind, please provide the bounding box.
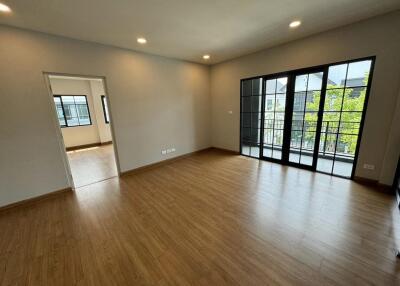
[317,60,372,177]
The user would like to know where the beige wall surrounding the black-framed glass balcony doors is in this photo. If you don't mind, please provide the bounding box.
[211,11,400,184]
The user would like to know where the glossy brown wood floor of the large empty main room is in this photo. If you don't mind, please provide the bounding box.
[0,150,400,286]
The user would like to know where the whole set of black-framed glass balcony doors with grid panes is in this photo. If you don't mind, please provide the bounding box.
[240,57,375,178]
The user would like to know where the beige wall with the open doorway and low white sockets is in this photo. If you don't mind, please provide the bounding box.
[0,26,211,206]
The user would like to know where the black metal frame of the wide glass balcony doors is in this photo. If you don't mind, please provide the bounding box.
[239,55,377,180]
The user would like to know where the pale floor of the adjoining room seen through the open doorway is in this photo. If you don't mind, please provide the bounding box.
[67,144,118,187]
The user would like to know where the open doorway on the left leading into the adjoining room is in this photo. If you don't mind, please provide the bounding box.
[45,74,118,188]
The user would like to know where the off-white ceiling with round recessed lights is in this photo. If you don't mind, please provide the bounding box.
[0,0,400,63]
